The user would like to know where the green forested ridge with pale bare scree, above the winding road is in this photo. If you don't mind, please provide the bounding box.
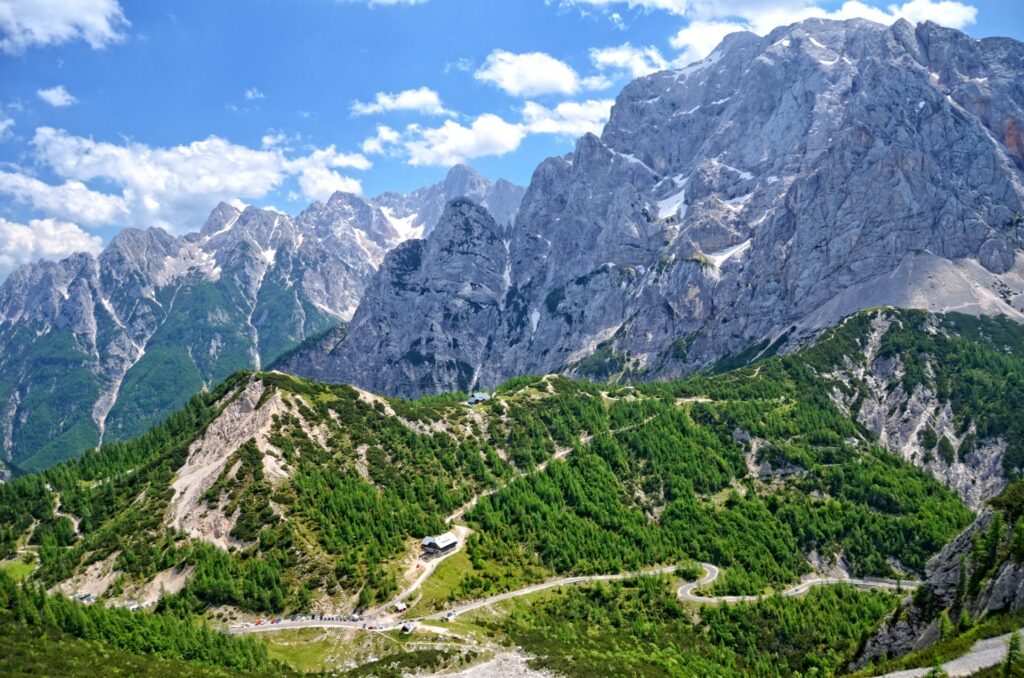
[0,312,999,612]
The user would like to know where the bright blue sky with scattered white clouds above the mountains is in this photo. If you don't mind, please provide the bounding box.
[0,0,1024,279]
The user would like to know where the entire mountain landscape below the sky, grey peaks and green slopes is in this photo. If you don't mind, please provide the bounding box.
[0,13,1024,676]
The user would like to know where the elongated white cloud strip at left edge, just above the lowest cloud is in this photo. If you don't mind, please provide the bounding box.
[0,172,129,226]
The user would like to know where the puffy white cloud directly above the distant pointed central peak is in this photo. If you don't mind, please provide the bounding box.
[402,113,526,166]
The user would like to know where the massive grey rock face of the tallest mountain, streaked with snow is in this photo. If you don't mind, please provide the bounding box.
[290,19,1024,395]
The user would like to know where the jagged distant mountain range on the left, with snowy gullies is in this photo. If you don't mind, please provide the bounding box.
[0,166,522,470]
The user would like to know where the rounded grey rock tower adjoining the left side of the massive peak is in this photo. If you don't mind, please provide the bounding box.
[331,199,508,392]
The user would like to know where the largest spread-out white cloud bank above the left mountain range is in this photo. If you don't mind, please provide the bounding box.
[0,127,371,232]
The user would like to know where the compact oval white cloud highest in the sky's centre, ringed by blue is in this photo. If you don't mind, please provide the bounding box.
[474,49,580,96]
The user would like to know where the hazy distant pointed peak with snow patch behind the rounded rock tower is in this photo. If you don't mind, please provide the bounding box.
[374,165,526,238]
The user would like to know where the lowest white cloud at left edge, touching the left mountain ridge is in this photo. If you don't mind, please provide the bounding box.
[0,217,102,280]
